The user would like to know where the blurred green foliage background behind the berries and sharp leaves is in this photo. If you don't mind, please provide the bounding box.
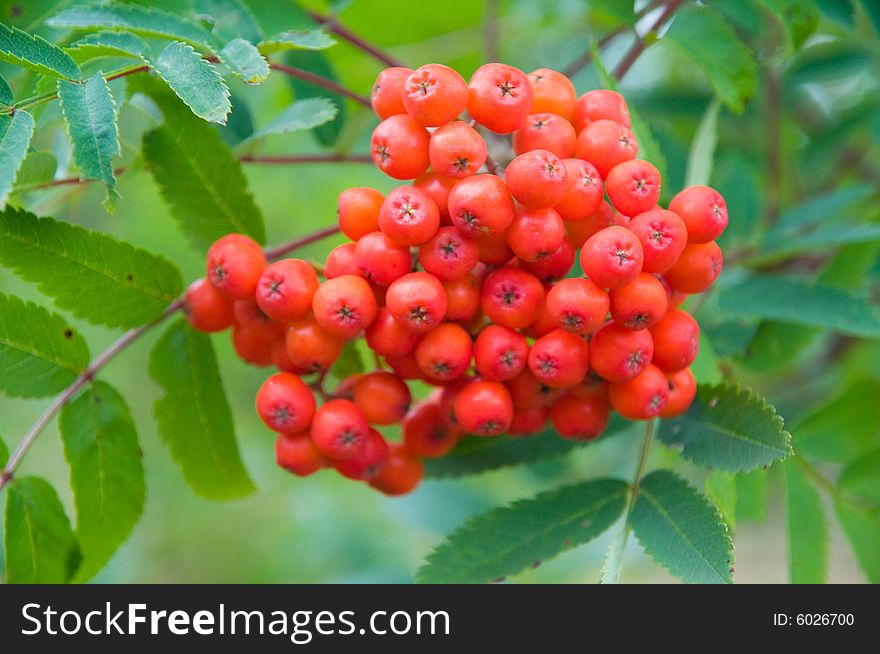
[0,0,880,583]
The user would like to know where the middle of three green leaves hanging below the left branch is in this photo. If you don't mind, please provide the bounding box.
[58,382,145,581]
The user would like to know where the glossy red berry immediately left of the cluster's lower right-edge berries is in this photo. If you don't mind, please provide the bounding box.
[590,321,654,382]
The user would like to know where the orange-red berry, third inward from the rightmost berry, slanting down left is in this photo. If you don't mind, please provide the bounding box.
[581,225,644,289]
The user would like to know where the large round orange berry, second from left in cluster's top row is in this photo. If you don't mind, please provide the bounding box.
[402,64,468,127]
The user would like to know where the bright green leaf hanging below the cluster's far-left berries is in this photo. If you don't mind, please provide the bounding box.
[150,320,254,499]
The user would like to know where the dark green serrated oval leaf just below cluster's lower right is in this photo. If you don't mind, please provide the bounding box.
[657,383,792,472]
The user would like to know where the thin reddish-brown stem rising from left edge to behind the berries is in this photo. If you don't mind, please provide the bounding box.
[0,225,339,490]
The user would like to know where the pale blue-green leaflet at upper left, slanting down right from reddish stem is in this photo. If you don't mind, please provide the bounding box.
[150,41,232,125]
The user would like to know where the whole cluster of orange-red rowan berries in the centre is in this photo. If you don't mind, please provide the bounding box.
[187,63,727,494]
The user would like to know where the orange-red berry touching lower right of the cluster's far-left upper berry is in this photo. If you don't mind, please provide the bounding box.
[256,259,319,322]
